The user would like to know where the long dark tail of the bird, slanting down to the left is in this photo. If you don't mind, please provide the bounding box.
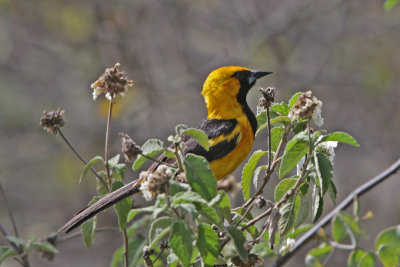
[58,180,140,233]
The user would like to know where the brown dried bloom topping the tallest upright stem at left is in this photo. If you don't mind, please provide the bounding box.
[91,63,133,100]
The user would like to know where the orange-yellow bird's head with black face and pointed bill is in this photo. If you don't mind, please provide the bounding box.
[201,66,272,114]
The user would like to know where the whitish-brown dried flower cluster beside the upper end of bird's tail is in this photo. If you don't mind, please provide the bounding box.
[139,165,173,201]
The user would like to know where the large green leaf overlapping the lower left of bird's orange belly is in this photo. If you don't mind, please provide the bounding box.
[184,154,217,201]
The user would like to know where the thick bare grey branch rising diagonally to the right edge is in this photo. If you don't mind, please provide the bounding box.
[273,158,400,267]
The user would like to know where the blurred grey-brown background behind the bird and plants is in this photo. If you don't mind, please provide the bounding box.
[0,0,400,266]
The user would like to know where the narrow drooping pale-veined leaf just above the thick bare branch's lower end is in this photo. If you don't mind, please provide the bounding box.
[278,195,301,236]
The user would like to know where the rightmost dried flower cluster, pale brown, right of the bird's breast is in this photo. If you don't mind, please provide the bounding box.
[289,91,324,126]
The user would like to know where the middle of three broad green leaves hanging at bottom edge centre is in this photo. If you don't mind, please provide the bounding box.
[197,224,219,265]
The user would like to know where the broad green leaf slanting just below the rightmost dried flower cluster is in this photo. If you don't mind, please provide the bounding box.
[279,132,310,178]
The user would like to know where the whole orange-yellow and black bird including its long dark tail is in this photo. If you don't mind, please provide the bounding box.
[59,66,272,232]
